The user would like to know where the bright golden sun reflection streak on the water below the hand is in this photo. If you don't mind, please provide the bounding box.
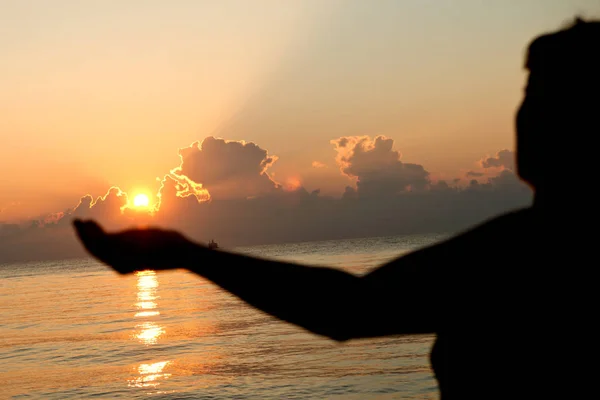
[128,271,171,388]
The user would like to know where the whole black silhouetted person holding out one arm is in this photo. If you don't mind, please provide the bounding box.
[75,20,600,400]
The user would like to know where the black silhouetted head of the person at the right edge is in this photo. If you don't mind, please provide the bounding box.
[516,18,600,192]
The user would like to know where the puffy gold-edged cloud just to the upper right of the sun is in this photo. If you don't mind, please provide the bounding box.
[172,136,280,199]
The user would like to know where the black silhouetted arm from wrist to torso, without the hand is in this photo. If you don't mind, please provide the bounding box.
[186,246,435,341]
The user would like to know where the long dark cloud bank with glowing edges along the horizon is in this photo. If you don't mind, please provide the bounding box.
[0,136,532,263]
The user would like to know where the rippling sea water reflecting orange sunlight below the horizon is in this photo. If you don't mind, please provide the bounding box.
[0,234,447,400]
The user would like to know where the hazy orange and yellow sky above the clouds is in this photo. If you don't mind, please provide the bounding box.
[0,0,600,222]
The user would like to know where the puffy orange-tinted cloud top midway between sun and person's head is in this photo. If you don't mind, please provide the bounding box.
[331,136,430,196]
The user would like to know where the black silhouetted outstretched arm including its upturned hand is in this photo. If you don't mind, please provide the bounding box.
[75,221,437,341]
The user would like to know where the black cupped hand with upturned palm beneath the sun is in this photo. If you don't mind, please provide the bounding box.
[73,220,198,274]
